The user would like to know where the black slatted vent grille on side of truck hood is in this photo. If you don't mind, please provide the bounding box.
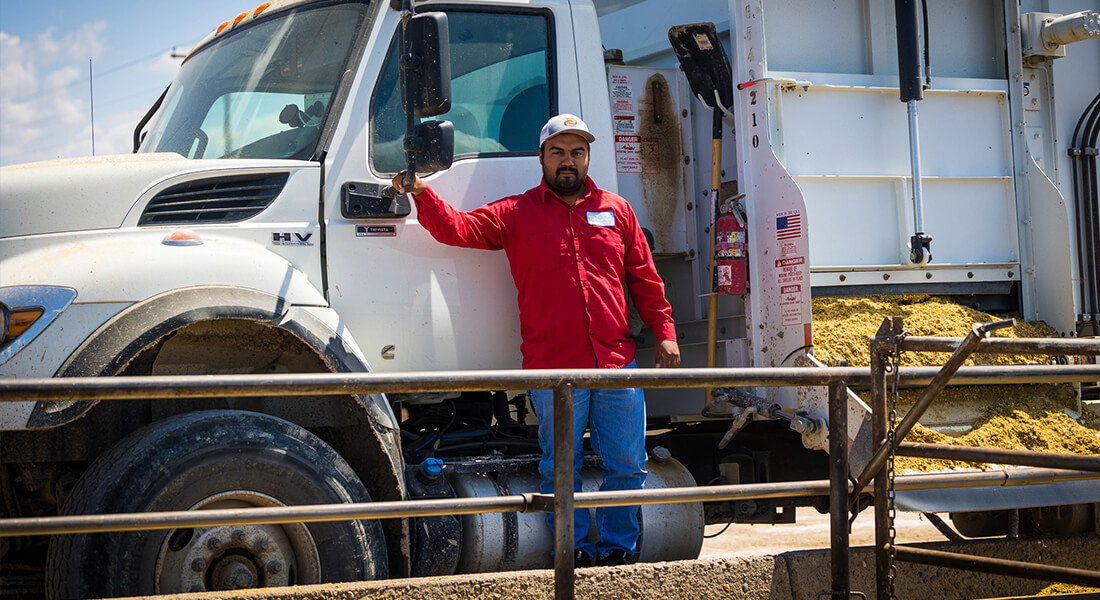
[138,173,289,226]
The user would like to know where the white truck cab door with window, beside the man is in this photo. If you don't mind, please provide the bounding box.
[325,4,579,371]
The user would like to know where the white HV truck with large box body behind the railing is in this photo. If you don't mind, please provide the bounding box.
[0,0,1100,598]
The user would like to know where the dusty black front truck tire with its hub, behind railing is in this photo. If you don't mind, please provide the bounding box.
[46,411,388,599]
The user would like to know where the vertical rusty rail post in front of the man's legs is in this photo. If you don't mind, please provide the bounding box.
[553,383,574,600]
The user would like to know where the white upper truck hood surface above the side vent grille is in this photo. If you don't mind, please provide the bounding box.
[0,153,297,238]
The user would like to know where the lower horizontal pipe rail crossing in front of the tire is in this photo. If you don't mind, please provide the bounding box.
[0,469,1100,537]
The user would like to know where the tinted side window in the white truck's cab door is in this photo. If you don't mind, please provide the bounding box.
[371,11,551,174]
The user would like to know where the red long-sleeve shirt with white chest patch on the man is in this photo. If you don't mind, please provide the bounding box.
[414,178,675,369]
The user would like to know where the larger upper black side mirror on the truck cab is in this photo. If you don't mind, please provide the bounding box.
[400,12,451,119]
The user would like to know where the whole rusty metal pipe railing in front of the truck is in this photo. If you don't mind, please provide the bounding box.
[0,331,1100,599]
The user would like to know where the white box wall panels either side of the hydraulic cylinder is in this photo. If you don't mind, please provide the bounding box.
[773,74,1019,274]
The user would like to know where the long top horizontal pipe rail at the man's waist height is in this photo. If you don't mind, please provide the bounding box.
[0,363,1100,402]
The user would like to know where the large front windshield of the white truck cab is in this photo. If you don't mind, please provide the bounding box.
[139,2,366,160]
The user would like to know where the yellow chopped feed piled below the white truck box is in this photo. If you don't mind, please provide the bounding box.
[813,296,1100,472]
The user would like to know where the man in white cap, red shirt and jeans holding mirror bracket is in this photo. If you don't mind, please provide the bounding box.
[393,114,680,567]
